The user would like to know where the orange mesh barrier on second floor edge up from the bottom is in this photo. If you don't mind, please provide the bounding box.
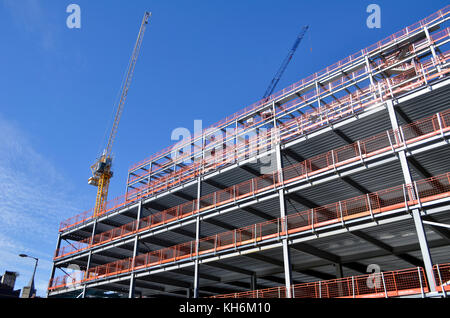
[50,172,450,290]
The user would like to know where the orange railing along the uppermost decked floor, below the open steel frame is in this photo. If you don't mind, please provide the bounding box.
[60,21,450,231]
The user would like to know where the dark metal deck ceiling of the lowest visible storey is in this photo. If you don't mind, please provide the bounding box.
[55,217,450,296]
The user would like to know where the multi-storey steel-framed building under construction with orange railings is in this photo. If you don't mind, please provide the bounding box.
[48,6,450,298]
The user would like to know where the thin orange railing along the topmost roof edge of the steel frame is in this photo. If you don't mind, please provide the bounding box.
[129,5,450,174]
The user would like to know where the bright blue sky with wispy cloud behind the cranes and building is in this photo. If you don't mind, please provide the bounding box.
[0,0,447,295]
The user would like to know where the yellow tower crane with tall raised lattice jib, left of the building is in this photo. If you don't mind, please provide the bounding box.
[88,12,151,217]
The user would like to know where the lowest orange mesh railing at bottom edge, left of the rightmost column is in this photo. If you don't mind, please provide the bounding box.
[210,267,429,298]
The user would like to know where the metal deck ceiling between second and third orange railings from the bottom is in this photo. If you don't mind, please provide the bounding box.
[57,138,450,270]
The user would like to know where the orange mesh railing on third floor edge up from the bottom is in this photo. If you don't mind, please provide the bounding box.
[55,109,450,258]
